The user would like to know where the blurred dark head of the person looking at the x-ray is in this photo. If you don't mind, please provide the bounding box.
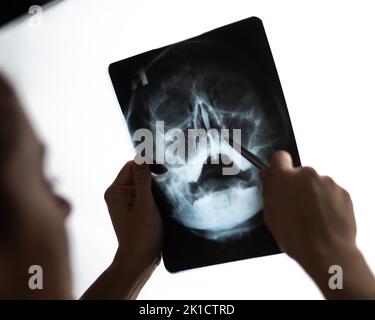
[0,75,71,299]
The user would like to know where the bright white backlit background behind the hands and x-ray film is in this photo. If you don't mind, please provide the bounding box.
[0,0,375,299]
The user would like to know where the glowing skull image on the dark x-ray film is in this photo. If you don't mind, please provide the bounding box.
[125,41,280,241]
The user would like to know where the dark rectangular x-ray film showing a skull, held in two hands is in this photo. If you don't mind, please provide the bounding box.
[109,17,300,272]
